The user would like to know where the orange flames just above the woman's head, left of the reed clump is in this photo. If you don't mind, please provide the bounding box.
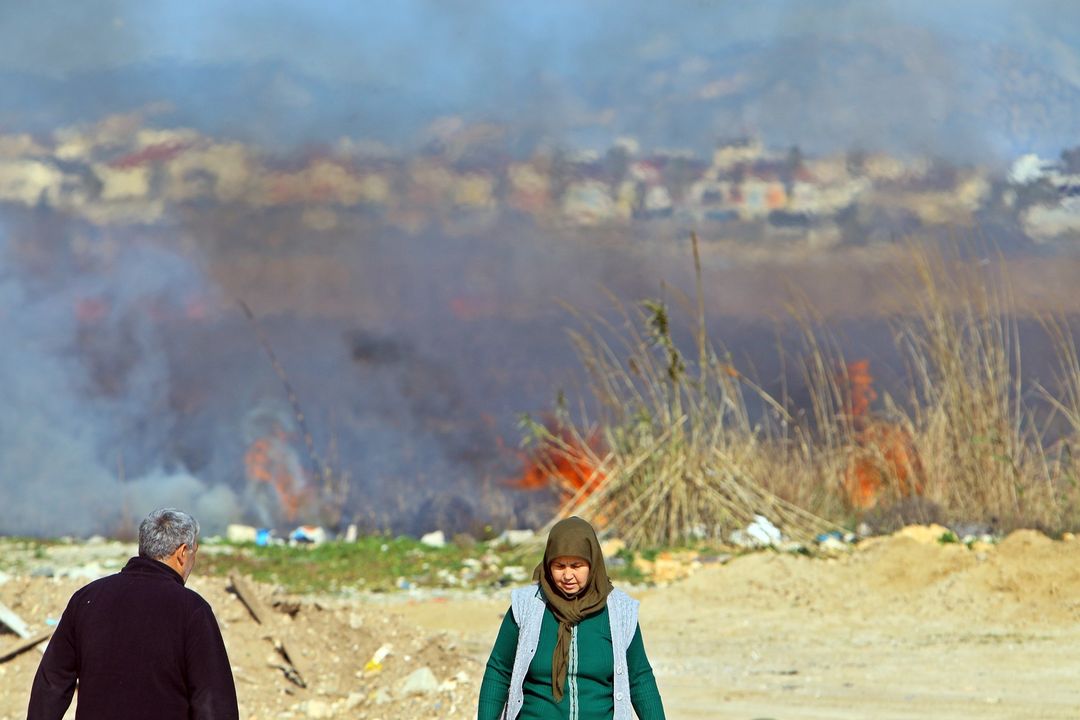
[513,422,605,502]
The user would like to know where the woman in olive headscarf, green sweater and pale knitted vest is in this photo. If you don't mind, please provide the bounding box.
[477,517,664,720]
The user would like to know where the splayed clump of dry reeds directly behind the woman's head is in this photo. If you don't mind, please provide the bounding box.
[530,237,834,546]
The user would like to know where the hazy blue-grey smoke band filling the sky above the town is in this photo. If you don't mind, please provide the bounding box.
[0,0,1080,162]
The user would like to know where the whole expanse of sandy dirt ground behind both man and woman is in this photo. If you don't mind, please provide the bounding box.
[6,529,1080,720]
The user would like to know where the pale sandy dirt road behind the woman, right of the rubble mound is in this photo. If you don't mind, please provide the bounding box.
[401,532,1080,720]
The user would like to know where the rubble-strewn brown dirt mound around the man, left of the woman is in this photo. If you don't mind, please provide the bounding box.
[0,575,483,720]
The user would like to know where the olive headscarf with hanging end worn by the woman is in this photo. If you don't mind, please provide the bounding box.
[532,517,612,703]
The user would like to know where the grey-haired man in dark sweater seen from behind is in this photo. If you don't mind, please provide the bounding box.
[27,508,239,720]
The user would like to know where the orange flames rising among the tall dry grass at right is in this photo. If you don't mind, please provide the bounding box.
[843,359,922,511]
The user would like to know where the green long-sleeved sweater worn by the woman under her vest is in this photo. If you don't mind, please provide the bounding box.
[476,608,665,720]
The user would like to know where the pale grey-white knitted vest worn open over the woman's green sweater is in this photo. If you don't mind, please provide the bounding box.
[502,585,638,720]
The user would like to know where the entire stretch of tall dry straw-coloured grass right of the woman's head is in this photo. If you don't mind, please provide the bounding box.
[530,239,1080,545]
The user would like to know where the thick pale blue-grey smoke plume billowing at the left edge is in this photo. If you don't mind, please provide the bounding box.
[0,216,243,535]
